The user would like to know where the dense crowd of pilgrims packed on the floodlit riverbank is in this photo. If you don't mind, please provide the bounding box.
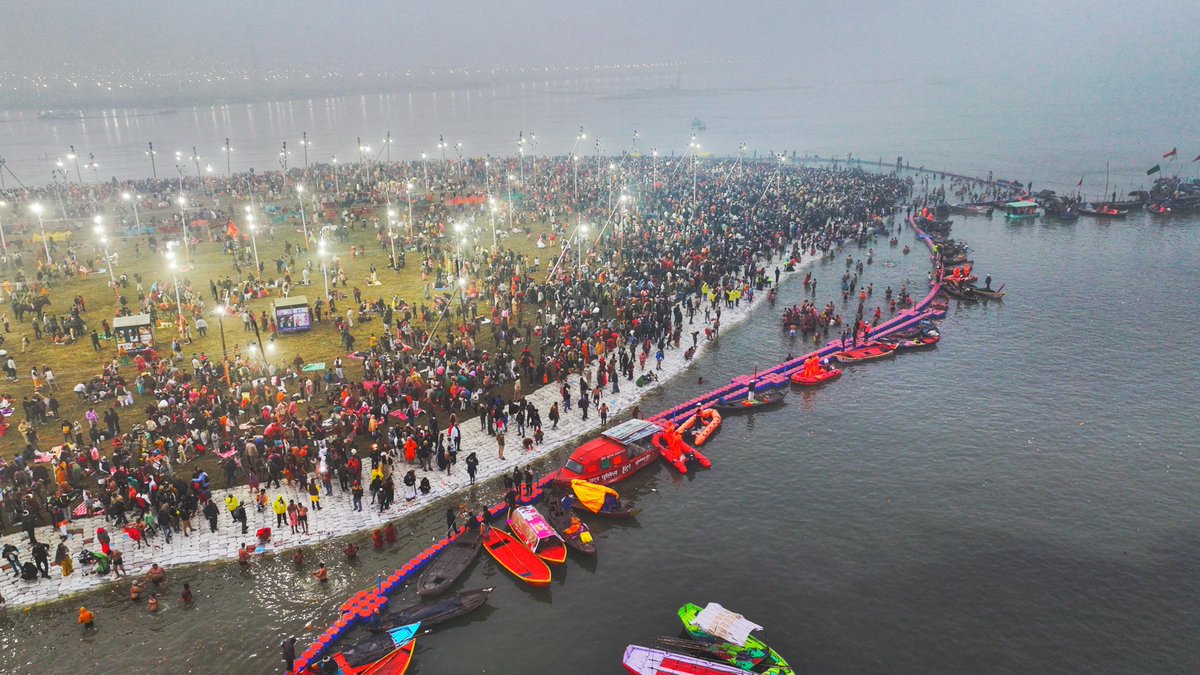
[0,156,912,598]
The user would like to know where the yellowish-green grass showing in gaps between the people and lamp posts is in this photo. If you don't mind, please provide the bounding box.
[0,192,557,456]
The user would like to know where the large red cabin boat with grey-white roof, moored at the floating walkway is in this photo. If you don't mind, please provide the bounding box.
[554,419,662,485]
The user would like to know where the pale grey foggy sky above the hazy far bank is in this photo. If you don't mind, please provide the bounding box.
[0,0,1200,89]
